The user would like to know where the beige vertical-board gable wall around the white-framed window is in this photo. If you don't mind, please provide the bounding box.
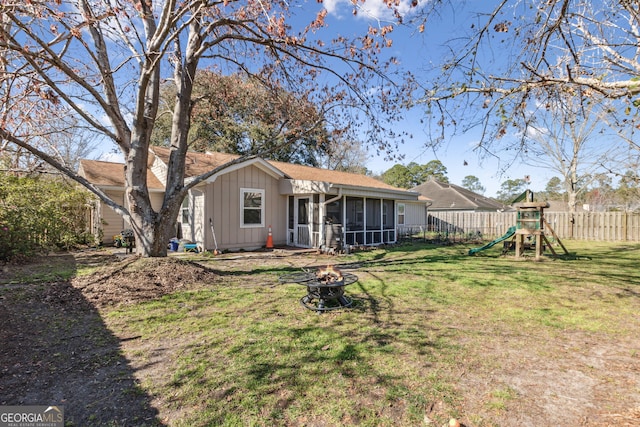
[203,166,287,249]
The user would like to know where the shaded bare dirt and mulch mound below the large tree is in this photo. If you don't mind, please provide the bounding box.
[0,252,218,426]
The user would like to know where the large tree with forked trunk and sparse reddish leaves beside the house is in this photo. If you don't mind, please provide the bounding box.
[0,0,416,256]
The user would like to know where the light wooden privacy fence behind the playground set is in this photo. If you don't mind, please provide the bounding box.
[427,212,640,242]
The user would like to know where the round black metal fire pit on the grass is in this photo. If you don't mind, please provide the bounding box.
[280,265,358,313]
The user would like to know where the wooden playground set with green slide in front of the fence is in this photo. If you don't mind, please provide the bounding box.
[469,190,569,259]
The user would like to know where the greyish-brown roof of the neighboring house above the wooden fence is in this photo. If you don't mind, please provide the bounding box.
[412,179,511,211]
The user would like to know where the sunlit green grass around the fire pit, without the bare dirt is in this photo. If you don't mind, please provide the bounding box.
[96,242,640,426]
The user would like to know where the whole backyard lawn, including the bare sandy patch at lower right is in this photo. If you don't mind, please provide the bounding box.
[0,241,640,427]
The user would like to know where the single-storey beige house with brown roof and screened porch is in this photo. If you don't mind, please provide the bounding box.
[79,147,427,250]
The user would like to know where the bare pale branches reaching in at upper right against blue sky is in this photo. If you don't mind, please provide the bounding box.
[422,0,640,157]
